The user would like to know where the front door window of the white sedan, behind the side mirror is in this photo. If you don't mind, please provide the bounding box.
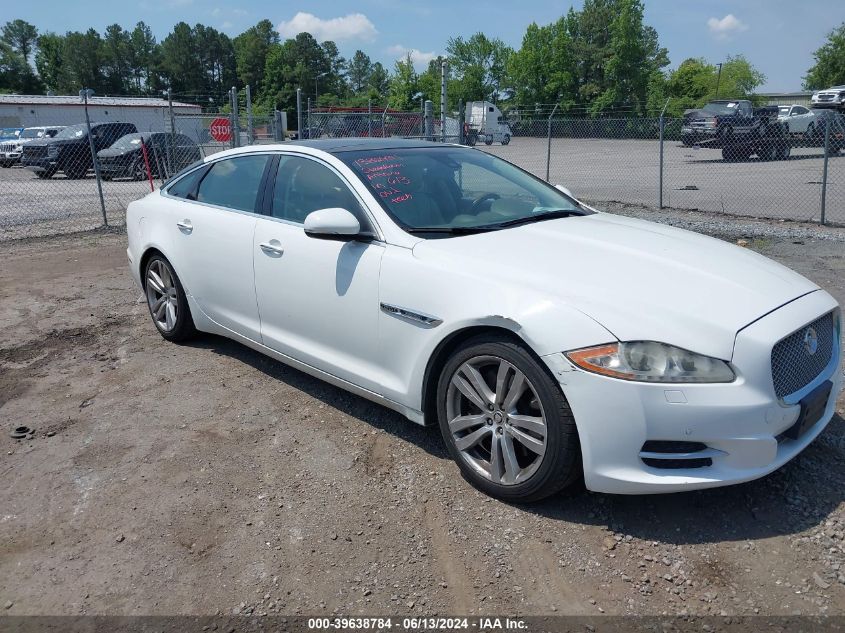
[271,156,362,227]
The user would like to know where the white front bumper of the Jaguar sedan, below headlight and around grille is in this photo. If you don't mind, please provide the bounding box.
[543,291,842,494]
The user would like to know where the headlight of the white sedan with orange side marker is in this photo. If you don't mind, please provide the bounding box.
[566,341,736,383]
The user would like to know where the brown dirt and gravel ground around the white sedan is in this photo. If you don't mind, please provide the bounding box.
[0,207,845,615]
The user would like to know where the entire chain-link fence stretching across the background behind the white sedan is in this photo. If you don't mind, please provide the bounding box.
[0,93,845,240]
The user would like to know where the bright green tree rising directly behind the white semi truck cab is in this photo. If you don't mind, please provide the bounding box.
[446,33,513,101]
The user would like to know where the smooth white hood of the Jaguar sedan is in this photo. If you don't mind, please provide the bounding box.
[413,213,818,360]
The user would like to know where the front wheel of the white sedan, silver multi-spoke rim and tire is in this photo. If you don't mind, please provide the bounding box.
[437,335,582,502]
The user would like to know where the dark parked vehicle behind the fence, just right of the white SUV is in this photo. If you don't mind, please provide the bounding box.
[21,123,138,178]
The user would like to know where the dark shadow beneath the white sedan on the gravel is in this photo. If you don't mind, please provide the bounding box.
[190,334,845,545]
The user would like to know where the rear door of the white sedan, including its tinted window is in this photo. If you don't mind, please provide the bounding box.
[163,154,273,341]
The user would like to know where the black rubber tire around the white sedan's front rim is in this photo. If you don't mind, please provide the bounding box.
[437,335,583,503]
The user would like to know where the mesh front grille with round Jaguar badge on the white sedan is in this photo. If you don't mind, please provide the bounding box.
[772,312,834,398]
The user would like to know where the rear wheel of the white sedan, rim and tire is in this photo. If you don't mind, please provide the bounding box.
[144,255,196,343]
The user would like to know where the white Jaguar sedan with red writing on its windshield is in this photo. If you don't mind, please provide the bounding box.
[127,139,842,501]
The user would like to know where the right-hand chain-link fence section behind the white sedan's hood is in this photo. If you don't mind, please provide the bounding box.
[479,110,845,225]
